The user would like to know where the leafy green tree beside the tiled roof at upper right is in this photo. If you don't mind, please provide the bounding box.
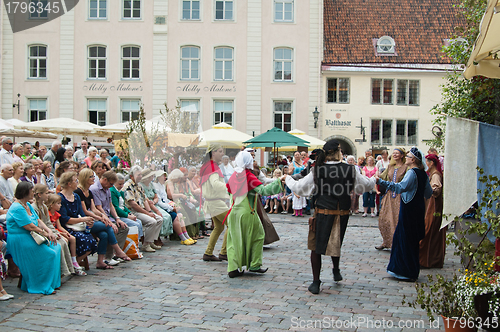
[430,0,500,150]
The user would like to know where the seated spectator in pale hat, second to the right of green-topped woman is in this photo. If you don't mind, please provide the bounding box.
[140,168,174,247]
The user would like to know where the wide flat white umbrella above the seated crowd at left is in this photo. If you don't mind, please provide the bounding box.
[14,118,100,136]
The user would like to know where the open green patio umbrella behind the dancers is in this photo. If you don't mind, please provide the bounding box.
[243,127,309,168]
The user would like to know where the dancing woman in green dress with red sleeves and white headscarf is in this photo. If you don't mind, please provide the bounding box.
[226,151,283,278]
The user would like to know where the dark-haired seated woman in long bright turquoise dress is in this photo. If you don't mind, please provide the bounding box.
[7,182,61,295]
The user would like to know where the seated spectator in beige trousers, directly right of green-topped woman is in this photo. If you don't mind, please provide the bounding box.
[123,166,163,252]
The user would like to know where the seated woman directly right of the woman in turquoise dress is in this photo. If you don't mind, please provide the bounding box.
[33,183,87,276]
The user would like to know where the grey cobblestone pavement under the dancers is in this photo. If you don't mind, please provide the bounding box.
[0,215,459,331]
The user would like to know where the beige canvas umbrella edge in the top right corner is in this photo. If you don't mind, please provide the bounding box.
[464,0,500,79]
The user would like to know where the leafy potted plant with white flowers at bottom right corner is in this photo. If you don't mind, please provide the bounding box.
[403,169,500,331]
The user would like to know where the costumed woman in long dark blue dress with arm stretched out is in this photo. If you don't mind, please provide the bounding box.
[376,147,432,281]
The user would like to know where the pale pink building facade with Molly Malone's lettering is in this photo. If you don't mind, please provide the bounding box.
[1,0,323,148]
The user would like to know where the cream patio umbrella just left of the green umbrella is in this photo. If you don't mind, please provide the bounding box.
[198,122,253,148]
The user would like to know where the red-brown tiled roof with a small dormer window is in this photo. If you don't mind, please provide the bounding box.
[323,0,463,65]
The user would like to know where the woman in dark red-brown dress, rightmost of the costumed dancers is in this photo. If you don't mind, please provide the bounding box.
[420,155,447,268]
